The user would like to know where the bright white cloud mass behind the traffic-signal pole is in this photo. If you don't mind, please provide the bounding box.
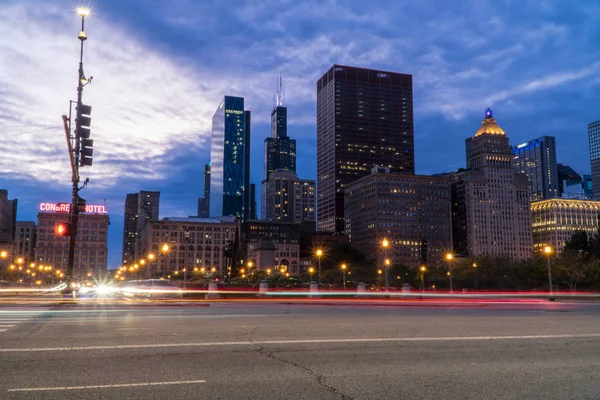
[0,3,217,187]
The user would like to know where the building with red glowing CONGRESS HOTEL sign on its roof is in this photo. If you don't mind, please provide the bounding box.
[34,203,110,280]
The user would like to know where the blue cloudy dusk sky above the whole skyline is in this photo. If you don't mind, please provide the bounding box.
[0,0,600,269]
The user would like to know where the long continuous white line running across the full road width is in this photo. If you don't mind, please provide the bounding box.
[0,333,600,353]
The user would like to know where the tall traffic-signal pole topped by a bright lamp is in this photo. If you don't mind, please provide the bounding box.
[63,7,93,296]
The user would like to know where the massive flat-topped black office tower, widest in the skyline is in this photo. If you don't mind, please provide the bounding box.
[317,65,415,232]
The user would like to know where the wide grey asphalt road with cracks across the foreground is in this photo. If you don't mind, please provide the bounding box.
[0,303,600,399]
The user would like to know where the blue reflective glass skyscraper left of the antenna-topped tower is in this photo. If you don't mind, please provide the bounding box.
[210,96,250,222]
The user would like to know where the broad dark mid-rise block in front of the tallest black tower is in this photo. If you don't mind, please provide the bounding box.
[344,167,452,268]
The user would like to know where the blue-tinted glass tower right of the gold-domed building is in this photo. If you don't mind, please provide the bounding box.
[512,136,559,201]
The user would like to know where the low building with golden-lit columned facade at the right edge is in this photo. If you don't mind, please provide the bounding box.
[531,199,600,253]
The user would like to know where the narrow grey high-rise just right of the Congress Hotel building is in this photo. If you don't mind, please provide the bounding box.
[123,190,160,264]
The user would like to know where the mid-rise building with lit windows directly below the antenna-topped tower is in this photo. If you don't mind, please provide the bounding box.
[263,170,315,222]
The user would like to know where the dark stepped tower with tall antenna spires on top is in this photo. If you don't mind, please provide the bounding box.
[264,77,296,180]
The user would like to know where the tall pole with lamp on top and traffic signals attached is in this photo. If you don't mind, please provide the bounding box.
[63,7,91,296]
